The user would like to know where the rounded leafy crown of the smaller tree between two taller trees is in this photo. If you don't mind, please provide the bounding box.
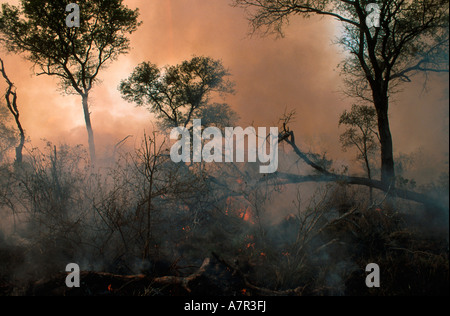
[119,57,236,128]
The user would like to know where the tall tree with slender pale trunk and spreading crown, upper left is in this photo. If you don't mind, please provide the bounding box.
[0,0,139,162]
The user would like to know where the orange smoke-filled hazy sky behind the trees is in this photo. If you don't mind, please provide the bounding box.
[0,0,449,181]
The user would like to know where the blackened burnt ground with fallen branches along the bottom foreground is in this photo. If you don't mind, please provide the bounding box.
[0,205,449,296]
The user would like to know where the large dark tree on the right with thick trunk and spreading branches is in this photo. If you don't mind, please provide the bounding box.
[233,0,449,186]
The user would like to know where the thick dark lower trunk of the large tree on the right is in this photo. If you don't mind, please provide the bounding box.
[374,93,395,189]
